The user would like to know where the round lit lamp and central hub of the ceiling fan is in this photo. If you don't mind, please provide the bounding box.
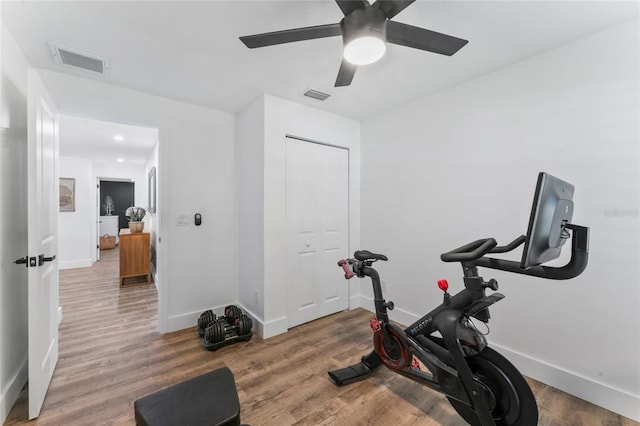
[340,7,387,65]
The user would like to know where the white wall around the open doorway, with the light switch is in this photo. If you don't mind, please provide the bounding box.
[41,71,238,332]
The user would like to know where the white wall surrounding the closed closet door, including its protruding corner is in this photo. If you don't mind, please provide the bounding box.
[236,95,360,337]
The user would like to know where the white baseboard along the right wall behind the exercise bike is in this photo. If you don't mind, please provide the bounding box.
[359,295,640,422]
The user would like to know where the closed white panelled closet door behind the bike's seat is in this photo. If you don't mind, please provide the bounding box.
[286,138,349,327]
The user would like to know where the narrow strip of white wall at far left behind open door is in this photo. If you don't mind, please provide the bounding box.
[0,20,28,423]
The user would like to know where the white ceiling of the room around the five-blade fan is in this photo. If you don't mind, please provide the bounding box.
[1,0,639,161]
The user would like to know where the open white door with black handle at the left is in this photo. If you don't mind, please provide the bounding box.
[28,70,59,419]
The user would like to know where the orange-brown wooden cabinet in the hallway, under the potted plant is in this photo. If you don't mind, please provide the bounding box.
[120,229,151,287]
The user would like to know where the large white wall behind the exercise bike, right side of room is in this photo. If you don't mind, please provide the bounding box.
[362,21,640,420]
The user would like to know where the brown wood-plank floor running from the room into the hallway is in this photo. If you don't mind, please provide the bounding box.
[5,250,638,426]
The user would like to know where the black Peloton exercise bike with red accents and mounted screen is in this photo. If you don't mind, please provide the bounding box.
[329,173,589,426]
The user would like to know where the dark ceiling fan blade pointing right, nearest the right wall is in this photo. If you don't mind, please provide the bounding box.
[387,21,469,56]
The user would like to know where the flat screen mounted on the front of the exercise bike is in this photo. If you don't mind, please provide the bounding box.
[520,172,574,269]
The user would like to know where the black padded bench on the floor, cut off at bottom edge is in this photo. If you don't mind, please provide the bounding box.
[133,367,240,426]
